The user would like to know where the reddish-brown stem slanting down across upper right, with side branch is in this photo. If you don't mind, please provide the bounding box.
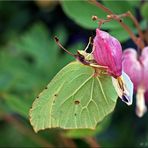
[89,0,144,49]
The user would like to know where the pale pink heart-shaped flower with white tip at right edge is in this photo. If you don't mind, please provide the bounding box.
[122,47,148,117]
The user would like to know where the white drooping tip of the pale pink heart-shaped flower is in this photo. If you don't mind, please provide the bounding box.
[136,87,147,118]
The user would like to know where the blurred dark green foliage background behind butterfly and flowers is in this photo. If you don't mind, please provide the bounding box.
[0,0,148,147]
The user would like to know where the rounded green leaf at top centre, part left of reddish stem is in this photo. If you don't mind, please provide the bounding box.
[61,1,105,29]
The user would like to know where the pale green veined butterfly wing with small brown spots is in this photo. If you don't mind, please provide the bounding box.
[30,61,117,132]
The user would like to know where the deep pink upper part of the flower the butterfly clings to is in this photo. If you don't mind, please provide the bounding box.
[93,29,122,78]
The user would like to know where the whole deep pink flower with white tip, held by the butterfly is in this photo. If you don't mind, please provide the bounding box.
[92,29,133,105]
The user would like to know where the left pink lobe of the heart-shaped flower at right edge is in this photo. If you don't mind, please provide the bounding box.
[122,48,142,91]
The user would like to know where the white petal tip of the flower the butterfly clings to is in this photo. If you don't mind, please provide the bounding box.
[112,71,133,105]
